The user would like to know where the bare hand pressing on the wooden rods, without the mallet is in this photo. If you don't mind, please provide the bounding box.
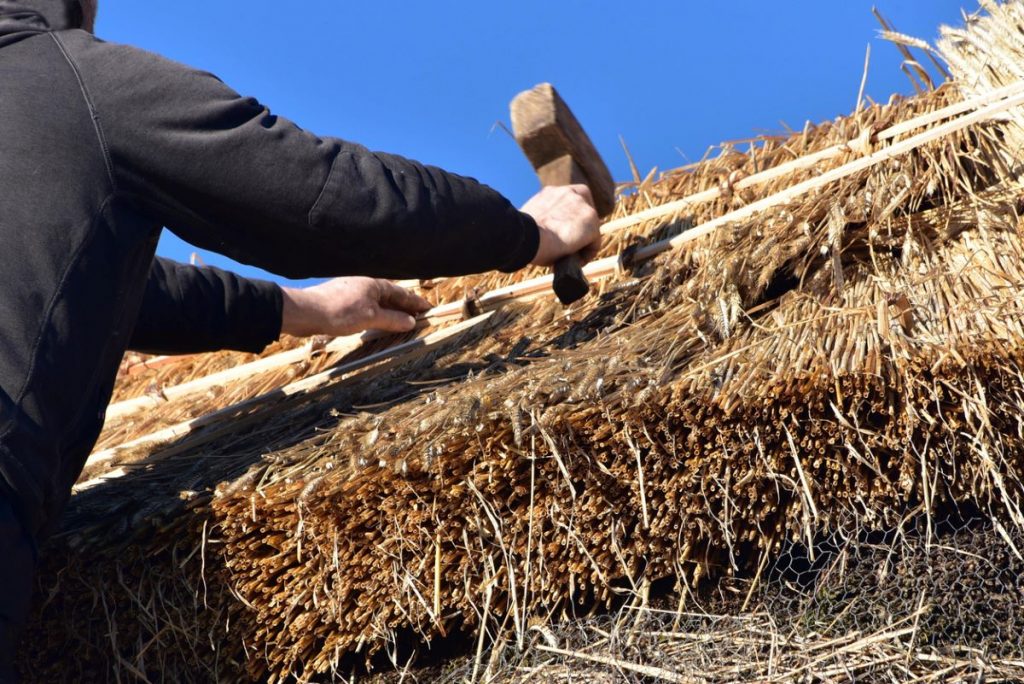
[281,277,430,337]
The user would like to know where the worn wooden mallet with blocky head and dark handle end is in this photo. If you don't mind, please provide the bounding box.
[511,83,615,305]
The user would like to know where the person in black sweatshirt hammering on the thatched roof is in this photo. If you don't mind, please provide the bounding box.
[0,0,599,679]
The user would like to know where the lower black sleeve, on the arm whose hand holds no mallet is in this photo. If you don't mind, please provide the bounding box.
[129,258,282,354]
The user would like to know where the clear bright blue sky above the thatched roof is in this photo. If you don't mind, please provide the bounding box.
[96,0,977,282]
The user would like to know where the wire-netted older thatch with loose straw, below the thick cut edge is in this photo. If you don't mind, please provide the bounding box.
[438,511,1024,684]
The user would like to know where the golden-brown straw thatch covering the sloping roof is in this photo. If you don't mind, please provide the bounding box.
[18,2,1024,681]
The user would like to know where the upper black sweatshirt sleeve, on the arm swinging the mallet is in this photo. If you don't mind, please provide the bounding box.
[68,35,539,279]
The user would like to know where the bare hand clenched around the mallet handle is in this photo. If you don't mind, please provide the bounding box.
[522,185,601,266]
